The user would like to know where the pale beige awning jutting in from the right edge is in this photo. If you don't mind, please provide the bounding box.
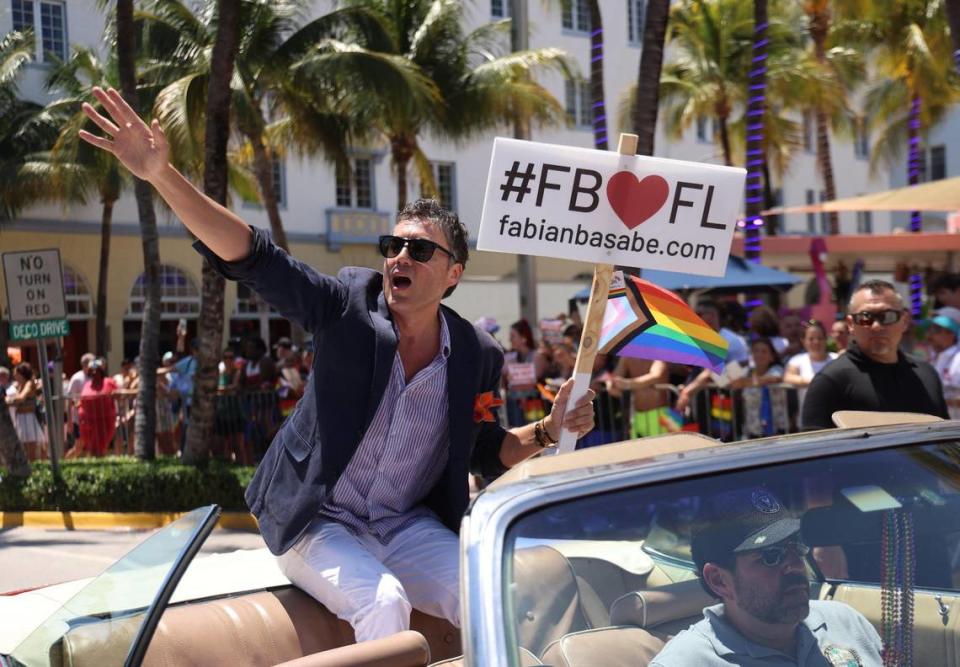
[762,176,960,215]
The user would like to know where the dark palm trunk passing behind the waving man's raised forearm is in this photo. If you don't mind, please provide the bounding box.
[184,0,240,463]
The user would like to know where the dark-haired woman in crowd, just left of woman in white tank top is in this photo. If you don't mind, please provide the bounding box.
[724,338,787,438]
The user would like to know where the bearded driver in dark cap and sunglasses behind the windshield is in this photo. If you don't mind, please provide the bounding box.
[650,488,883,667]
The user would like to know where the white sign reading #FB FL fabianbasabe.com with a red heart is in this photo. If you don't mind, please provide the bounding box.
[477,137,746,276]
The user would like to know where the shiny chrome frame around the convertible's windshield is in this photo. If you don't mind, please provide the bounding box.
[460,421,960,667]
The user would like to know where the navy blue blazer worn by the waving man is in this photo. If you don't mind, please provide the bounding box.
[194,229,506,555]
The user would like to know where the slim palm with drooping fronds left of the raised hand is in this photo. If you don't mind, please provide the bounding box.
[19,47,127,356]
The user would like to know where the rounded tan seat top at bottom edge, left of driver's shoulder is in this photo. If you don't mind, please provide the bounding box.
[541,627,664,667]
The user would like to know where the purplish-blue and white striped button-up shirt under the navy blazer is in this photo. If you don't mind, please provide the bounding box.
[319,317,450,544]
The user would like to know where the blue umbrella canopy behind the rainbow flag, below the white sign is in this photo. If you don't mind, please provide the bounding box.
[575,255,802,301]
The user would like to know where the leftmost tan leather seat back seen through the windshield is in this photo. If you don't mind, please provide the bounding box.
[513,546,591,655]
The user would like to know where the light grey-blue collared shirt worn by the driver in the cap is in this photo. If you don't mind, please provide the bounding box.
[650,600,883,667]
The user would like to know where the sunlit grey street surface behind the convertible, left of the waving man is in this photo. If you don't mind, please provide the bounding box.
[0,528,264,593]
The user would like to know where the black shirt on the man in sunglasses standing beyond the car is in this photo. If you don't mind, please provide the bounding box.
[802,341,947,428]
